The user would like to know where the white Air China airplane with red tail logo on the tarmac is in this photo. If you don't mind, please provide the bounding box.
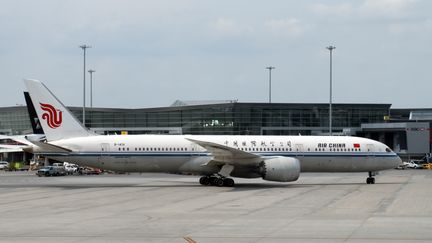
[24,80,402,187]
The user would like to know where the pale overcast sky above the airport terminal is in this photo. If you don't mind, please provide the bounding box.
[0,0,432,108]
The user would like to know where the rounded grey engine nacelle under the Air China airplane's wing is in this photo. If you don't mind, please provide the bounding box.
[261,157,300,182]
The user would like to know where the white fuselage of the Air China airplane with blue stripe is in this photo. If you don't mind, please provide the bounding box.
[37,135,401,177]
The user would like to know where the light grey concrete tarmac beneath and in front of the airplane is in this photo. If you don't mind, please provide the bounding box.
[0,170,432,242]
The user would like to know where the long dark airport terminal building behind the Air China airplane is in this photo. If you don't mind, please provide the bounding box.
[0,101,432,160]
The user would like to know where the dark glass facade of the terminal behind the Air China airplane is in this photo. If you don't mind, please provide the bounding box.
[0,103,390,135]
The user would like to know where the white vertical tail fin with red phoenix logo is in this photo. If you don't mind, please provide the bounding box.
[24,80,95,141]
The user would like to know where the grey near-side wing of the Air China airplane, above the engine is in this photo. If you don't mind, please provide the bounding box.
[186,138,263,166]
